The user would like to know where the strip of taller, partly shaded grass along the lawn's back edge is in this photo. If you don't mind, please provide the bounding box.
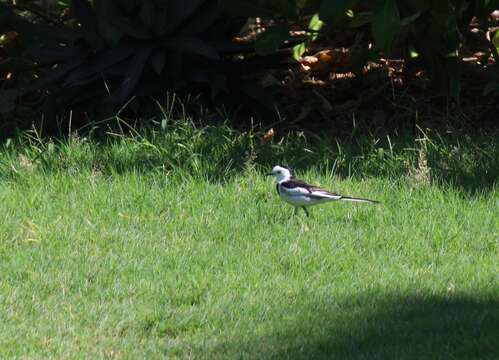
[0,123,499,195]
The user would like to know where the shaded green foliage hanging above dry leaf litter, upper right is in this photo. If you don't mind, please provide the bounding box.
[231,0,499,101]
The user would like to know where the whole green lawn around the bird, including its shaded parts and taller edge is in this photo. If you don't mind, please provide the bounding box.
[0,124,499,359]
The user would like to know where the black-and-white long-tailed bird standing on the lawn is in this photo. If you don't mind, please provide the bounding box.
[267,165,379,216]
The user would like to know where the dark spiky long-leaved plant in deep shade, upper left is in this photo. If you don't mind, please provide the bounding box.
[0,0,248,116]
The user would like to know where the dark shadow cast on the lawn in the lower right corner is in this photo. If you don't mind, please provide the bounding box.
[216,296,499,360]
